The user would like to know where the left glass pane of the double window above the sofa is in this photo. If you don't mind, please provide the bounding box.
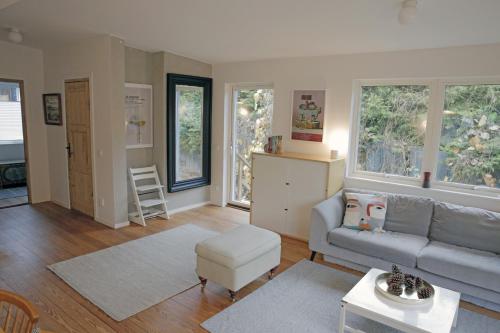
[356,85,429,177]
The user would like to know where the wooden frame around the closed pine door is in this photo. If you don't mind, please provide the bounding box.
[61,74,98,217]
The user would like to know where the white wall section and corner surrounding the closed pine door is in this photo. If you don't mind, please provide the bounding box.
[44,36,127,226]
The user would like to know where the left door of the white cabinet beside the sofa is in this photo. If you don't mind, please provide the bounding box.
[250,155,287,233]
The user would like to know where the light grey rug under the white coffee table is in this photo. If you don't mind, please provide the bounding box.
[201,260,500,333]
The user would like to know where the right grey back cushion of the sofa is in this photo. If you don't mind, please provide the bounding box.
[430,202,500,254]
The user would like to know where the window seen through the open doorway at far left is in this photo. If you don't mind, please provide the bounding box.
[0,82,23,144]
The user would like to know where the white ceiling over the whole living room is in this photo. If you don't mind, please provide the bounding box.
[0,0,500,63]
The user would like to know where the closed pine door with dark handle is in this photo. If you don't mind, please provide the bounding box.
[64,80,94,216]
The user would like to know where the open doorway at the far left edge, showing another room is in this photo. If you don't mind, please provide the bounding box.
[0,78,30,209]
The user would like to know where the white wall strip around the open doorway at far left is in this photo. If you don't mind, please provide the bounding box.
[0,41,50,203]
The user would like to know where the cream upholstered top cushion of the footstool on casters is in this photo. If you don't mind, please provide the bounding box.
[195,225,281,269]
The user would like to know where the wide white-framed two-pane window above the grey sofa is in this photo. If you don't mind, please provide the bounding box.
[349,79,500,192]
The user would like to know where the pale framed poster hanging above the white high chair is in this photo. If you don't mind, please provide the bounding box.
[125,83,153,149]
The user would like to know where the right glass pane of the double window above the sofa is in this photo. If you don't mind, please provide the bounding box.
[437,85,500,188]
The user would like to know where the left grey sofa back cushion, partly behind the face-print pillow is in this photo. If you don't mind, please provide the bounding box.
[344,188,434,237]
